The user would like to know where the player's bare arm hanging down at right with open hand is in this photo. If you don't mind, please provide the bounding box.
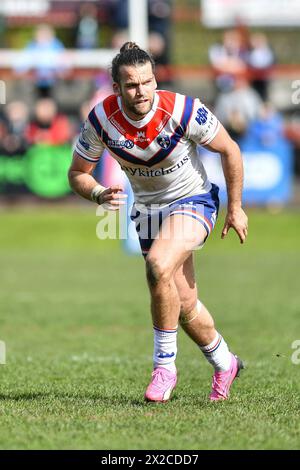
[206,126,248,243]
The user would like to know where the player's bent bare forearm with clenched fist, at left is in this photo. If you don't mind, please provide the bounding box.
[68,152,127,209]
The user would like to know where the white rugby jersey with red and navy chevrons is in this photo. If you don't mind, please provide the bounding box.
[75,90,220,205]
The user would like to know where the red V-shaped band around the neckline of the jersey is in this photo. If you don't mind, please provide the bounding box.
[103,91,176,150]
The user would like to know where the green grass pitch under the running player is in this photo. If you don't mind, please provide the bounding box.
[0,205,300,450]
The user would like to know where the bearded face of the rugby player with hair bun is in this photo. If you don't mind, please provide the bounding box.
[113,62,157,121]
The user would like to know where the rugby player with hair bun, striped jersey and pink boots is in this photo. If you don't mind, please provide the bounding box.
[69,42,248,402]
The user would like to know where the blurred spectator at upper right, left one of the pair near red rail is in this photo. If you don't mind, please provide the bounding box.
[209,29,248,91]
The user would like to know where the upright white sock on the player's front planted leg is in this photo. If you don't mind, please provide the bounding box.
[153,326,177,372]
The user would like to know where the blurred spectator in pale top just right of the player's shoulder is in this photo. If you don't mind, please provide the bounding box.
[215,77,262,140]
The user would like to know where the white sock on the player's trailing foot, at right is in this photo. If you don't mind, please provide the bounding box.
[199,332,231,372]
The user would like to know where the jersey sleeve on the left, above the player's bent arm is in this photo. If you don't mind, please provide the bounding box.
[75,115,105,163]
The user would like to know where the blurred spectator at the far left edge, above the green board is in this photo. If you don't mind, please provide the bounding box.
[0,101,29,156]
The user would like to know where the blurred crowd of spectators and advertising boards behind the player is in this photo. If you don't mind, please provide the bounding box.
[0,0,300,203]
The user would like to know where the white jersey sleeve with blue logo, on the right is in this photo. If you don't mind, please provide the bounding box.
[186,98,220,145]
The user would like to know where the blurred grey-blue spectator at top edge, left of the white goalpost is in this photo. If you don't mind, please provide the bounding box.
[75,3,99,49]
